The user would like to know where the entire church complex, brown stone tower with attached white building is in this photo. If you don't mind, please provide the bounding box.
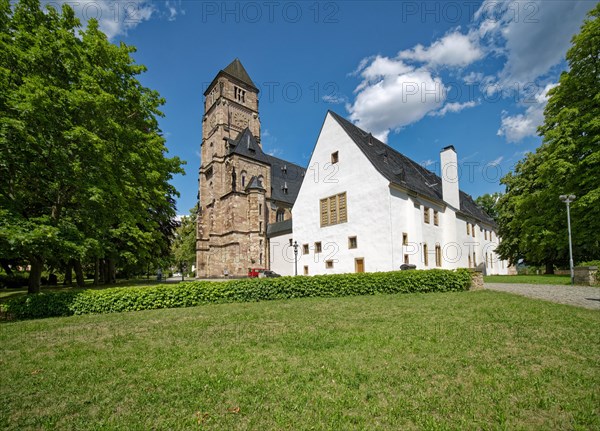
[197,59,508,278]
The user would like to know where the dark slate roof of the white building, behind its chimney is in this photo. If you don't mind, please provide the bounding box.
[329,111,495,226]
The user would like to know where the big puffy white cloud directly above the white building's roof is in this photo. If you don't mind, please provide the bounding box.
[346,61,445,142]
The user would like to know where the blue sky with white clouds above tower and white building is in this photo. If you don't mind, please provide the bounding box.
[50,0,596,214]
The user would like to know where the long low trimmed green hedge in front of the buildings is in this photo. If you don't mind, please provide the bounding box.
[5,269,471,319]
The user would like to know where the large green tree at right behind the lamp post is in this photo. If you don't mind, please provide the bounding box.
[498,5,600,272]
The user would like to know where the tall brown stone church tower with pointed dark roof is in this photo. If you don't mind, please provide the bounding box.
[196,58,271,278]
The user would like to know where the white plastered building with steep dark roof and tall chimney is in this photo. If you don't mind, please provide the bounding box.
[267,111,508,275]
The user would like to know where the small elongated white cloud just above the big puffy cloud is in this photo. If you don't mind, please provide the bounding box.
[398,31,484,67]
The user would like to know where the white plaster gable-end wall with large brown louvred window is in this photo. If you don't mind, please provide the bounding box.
[292,114,395,275]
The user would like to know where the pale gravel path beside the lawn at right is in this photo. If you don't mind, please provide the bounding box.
[484,283,600,310]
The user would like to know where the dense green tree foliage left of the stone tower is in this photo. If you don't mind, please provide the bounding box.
[0,0,183,292]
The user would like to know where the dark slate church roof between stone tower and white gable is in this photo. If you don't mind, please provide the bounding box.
[228,128,306,205]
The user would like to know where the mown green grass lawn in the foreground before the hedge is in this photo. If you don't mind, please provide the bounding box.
[0,291,600,430]
